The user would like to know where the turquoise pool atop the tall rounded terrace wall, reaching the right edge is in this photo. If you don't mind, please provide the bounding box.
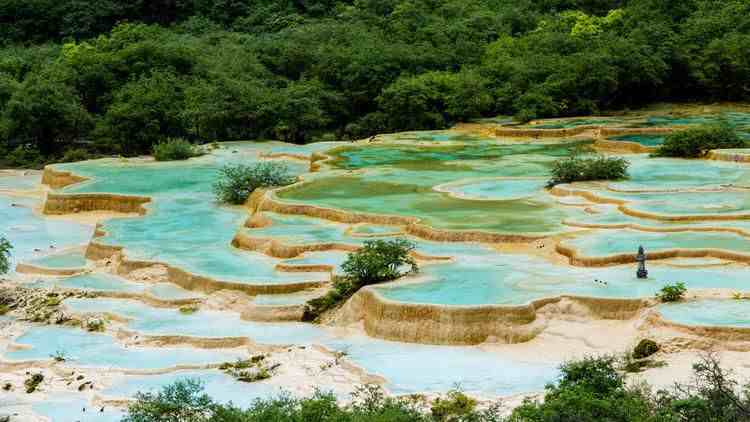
[377,242,750,305]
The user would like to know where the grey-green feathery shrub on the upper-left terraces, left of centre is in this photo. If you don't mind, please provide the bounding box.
[213,161,297,205]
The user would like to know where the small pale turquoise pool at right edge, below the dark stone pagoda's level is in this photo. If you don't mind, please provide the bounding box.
[659,299,750,327]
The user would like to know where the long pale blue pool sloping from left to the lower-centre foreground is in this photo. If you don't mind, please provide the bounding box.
[65,299,558,394]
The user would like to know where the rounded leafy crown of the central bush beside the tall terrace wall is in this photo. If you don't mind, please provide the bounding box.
[341,239,419,287]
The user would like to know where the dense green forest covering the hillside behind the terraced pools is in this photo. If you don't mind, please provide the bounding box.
[0,0,750,164]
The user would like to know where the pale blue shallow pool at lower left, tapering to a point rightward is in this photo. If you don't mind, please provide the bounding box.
[5,326,245,369]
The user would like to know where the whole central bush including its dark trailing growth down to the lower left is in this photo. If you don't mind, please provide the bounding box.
[303,239,419,321]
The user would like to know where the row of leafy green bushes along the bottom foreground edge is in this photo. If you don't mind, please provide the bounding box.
[123,350,750,422]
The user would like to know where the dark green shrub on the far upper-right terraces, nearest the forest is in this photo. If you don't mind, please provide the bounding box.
[654,125,746,158]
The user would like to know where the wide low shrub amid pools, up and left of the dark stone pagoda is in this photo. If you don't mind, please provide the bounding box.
[547,155,630,187]
